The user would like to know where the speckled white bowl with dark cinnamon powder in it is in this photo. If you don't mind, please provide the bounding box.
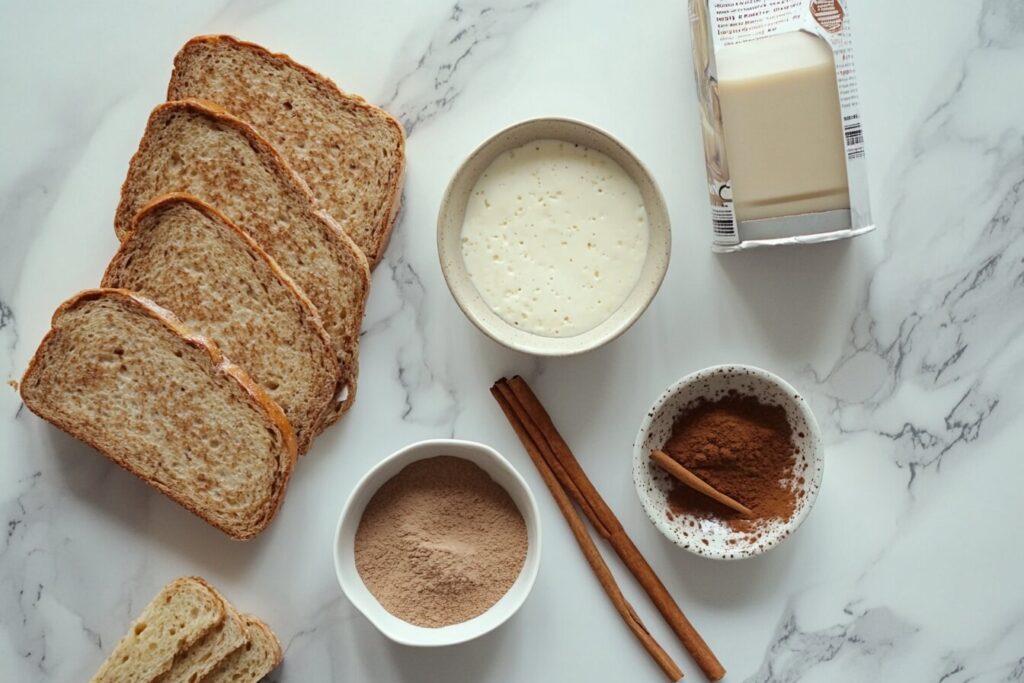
[633,366,823,559]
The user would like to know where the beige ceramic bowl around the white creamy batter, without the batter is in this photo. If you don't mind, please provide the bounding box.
[437,118,672,355]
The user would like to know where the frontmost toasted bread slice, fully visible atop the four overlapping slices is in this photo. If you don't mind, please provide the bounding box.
[20,289,296,539]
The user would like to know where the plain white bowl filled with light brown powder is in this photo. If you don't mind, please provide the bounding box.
[335,439,541,646]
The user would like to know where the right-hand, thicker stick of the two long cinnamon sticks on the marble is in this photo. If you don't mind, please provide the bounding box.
[495,376,725,681]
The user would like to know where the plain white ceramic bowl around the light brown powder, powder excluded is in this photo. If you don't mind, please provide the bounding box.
[334,439,541,647]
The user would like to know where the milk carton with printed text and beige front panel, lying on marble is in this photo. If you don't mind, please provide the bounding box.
[690,0,874,252]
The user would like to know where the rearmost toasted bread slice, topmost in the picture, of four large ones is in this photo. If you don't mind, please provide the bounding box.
[167,36,406,264]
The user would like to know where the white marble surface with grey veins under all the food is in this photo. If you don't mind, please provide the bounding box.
[0,0,1024,683]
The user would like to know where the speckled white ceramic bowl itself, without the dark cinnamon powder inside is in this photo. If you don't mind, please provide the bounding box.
[633,366,824,560]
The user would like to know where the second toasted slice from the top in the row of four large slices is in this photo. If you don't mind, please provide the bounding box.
[115,101,370,426]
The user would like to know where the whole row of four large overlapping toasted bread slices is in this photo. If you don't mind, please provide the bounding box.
[22,36,404,539]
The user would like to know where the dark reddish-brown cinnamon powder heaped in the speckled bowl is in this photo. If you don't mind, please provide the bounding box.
[664,392,798,533]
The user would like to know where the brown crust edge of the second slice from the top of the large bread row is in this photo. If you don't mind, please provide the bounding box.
[114,99,370,419]
